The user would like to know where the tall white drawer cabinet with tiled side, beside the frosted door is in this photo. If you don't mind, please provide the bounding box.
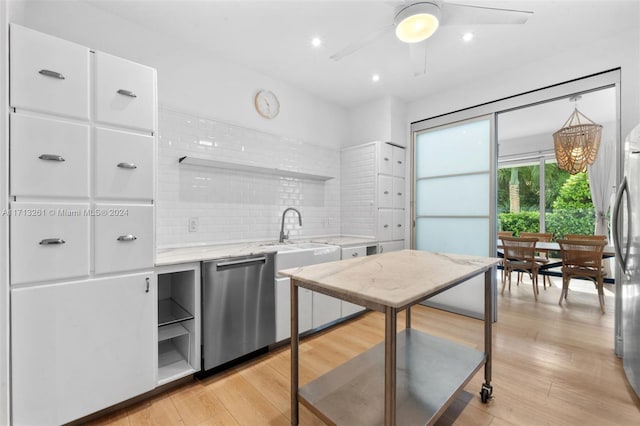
[340,142,408,253]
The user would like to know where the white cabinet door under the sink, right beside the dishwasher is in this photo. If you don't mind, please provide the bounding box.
[276,277,313,342]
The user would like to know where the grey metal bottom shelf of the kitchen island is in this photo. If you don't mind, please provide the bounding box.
[298,329,486,426]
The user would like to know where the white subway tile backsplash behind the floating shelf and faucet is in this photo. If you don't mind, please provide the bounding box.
[156,107,340,248]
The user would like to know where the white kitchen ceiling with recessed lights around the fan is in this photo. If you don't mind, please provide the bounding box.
[80,0,638,107]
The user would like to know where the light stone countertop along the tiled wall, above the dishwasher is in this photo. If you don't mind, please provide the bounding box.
[155,235,377,266]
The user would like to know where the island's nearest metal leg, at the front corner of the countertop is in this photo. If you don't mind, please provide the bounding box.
[384,306,398,426]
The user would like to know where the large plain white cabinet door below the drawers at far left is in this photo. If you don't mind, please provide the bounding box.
[11,272,157,425]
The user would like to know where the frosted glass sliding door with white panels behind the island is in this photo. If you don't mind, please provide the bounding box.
[414,116,495,318]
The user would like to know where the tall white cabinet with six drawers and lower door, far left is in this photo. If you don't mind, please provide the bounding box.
[9,24,158,424]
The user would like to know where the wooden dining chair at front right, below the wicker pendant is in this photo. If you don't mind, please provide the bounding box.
[558,239,607,314]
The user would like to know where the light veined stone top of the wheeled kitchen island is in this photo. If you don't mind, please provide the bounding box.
[279,250,500,312]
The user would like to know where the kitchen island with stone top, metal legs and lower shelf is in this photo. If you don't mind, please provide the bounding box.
[280,250,499,425]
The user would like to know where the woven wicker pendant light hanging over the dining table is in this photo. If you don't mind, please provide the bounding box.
[553,96,602,175]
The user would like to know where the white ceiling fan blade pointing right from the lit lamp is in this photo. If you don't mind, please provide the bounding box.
[440,3,533,25]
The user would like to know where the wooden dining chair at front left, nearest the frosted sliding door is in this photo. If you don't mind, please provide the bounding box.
[500,237,540,301]
